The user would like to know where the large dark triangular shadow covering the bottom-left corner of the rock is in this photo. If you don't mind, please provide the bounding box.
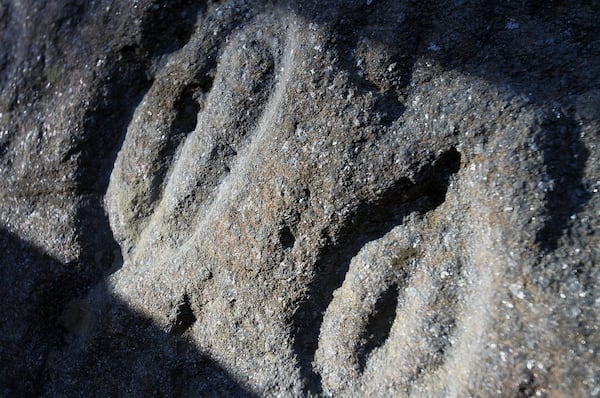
[0,229,253,397]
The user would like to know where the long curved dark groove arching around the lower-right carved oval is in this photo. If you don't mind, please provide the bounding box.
[292,148,460,394]
